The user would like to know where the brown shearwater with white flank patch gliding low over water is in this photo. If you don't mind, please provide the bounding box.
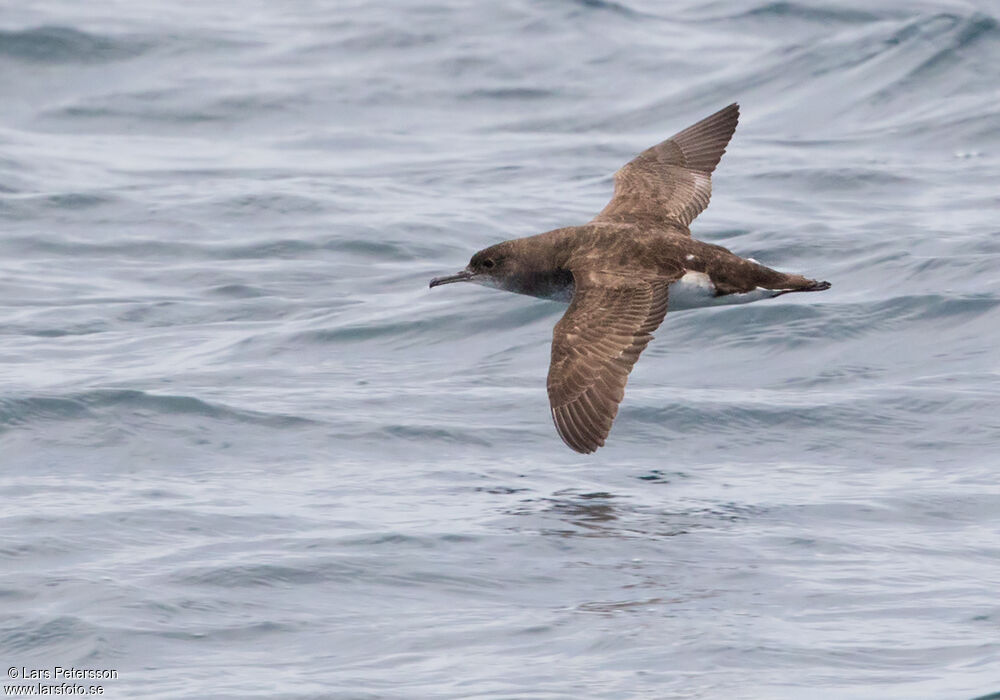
[430,104,830,453]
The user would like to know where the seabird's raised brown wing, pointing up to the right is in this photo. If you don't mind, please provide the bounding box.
[594,103,740,228]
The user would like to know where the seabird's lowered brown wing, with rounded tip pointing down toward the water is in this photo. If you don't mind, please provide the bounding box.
[548,270,683,453]
